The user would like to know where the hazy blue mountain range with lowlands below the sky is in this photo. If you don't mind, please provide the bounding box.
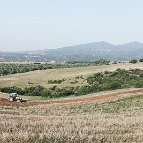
[0,41,143,61]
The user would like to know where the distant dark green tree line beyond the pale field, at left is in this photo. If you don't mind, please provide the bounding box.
[0,60,110,76]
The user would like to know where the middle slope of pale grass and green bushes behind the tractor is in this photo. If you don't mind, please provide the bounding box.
[0,63,143,99]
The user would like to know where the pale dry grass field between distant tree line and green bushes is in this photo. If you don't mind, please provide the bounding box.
[0,63,143,88]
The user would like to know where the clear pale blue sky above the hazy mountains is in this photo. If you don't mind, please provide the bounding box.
[0,0,143,51]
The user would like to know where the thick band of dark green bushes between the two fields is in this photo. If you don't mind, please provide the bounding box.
[0,69,143,98]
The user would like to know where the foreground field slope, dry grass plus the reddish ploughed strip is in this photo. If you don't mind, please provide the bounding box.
[0,89,143,143]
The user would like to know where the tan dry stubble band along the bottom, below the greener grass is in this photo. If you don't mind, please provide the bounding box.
[0,115,143,143]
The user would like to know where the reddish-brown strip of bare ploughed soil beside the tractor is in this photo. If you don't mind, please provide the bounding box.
[0,88,143,107]
